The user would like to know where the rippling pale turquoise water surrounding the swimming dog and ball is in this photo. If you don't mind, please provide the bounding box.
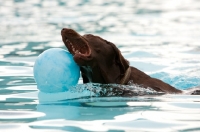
[0,0,200,132]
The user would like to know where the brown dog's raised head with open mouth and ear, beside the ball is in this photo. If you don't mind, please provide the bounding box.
[61,28,129,83]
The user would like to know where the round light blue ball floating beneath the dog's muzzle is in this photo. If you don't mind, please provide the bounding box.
[33,48,80,93]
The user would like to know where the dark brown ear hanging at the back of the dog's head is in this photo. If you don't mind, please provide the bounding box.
[105,40,129,74]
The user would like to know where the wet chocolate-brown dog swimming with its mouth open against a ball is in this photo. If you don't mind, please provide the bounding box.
[61,28,200,94]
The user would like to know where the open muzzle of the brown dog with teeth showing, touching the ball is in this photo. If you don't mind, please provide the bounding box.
[61,29,91,57]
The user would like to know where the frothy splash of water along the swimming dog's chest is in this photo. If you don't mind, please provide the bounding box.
[69,81,164,97]
